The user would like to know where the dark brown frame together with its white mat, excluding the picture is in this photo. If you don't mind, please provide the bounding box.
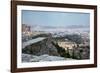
[11,1,97,73]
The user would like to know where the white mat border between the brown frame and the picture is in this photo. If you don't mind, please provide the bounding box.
[17,5,94,68]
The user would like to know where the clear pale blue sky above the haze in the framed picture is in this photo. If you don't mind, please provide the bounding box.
[22,10,90,26]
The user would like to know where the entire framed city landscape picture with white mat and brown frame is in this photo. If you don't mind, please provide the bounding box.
[11,1,97,73]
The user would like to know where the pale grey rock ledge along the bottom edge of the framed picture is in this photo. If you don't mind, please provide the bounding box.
[22,54,74,62]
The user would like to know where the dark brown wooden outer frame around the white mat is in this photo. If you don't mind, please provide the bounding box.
[11,1,97,73]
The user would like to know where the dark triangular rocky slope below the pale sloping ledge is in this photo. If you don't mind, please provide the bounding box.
[22,37,59,56]
